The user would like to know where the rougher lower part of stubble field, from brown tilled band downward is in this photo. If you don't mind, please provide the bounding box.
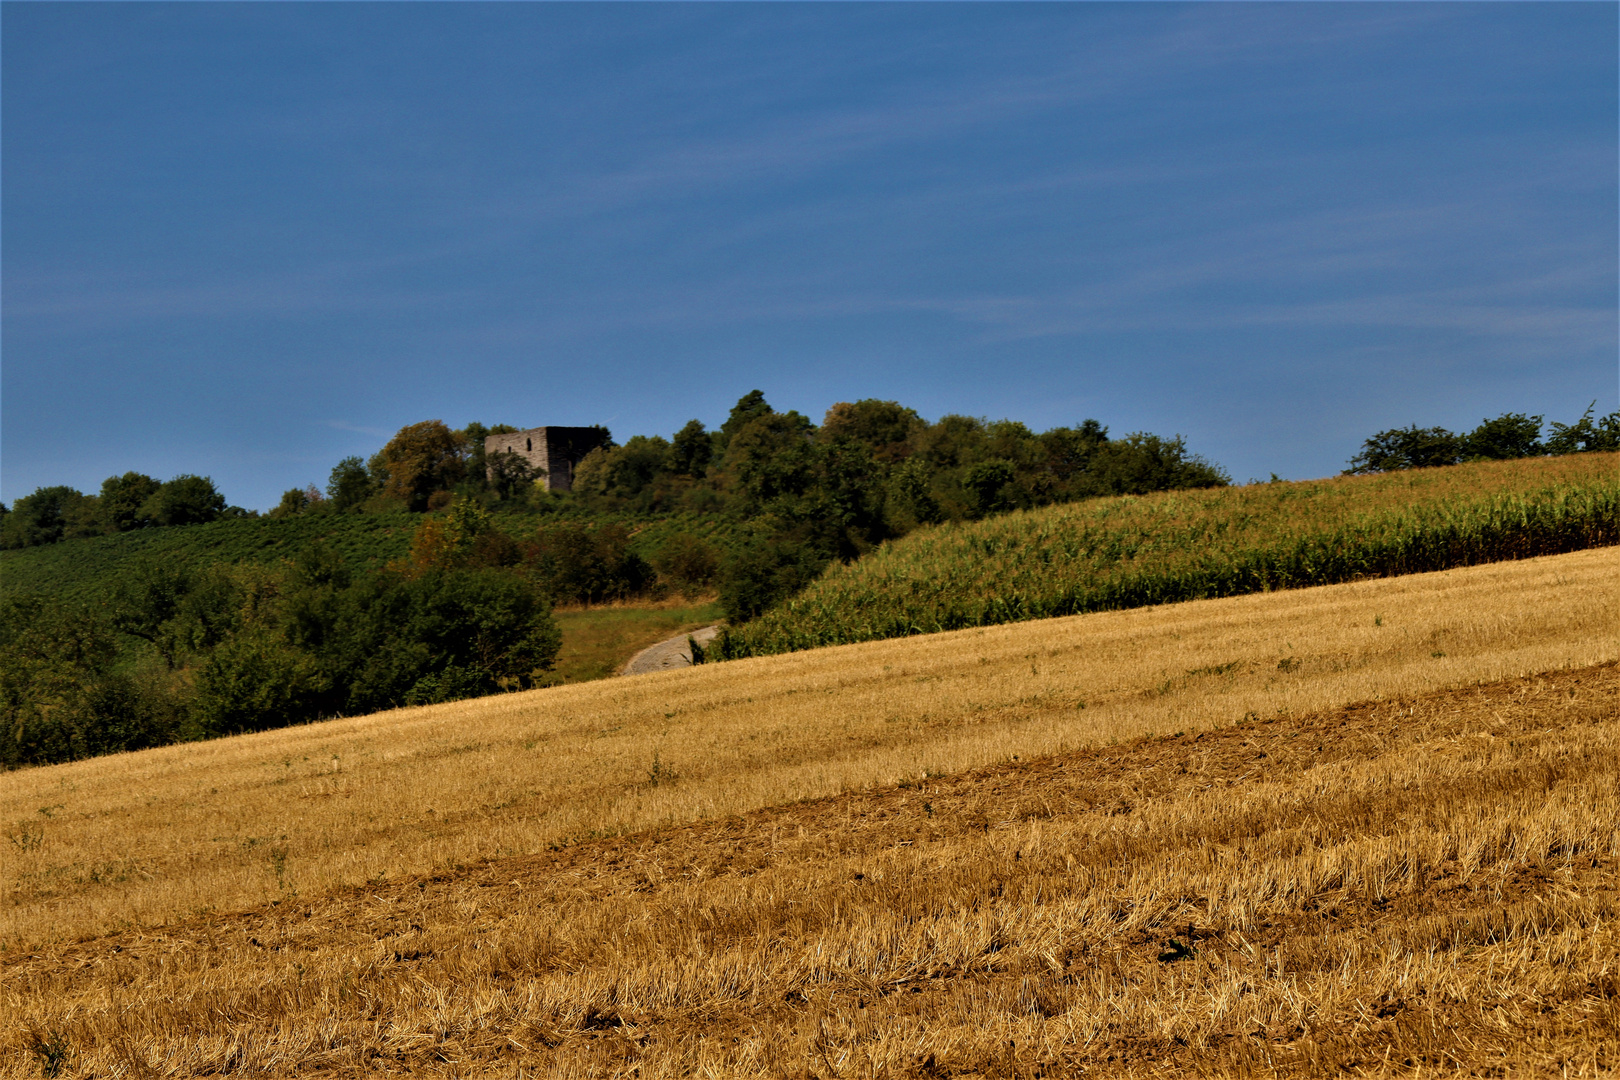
[0,664,1620,1077]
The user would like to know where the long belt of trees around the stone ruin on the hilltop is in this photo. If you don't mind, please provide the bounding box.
[272,390,1230,622]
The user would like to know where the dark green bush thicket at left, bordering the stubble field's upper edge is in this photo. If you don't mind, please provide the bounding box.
[0,539,561,767]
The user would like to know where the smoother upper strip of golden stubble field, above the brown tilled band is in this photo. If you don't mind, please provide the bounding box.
[0,549,1620,954]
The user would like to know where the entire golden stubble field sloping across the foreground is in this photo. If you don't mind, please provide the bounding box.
[0,549,1620,1077]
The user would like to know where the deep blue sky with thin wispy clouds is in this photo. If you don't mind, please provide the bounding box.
[0,3,1620,508]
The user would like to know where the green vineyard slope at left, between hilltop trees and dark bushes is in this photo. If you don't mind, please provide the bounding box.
[0,513,735,599]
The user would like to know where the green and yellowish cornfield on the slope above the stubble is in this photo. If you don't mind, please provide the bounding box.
[714,453,1620,657]
